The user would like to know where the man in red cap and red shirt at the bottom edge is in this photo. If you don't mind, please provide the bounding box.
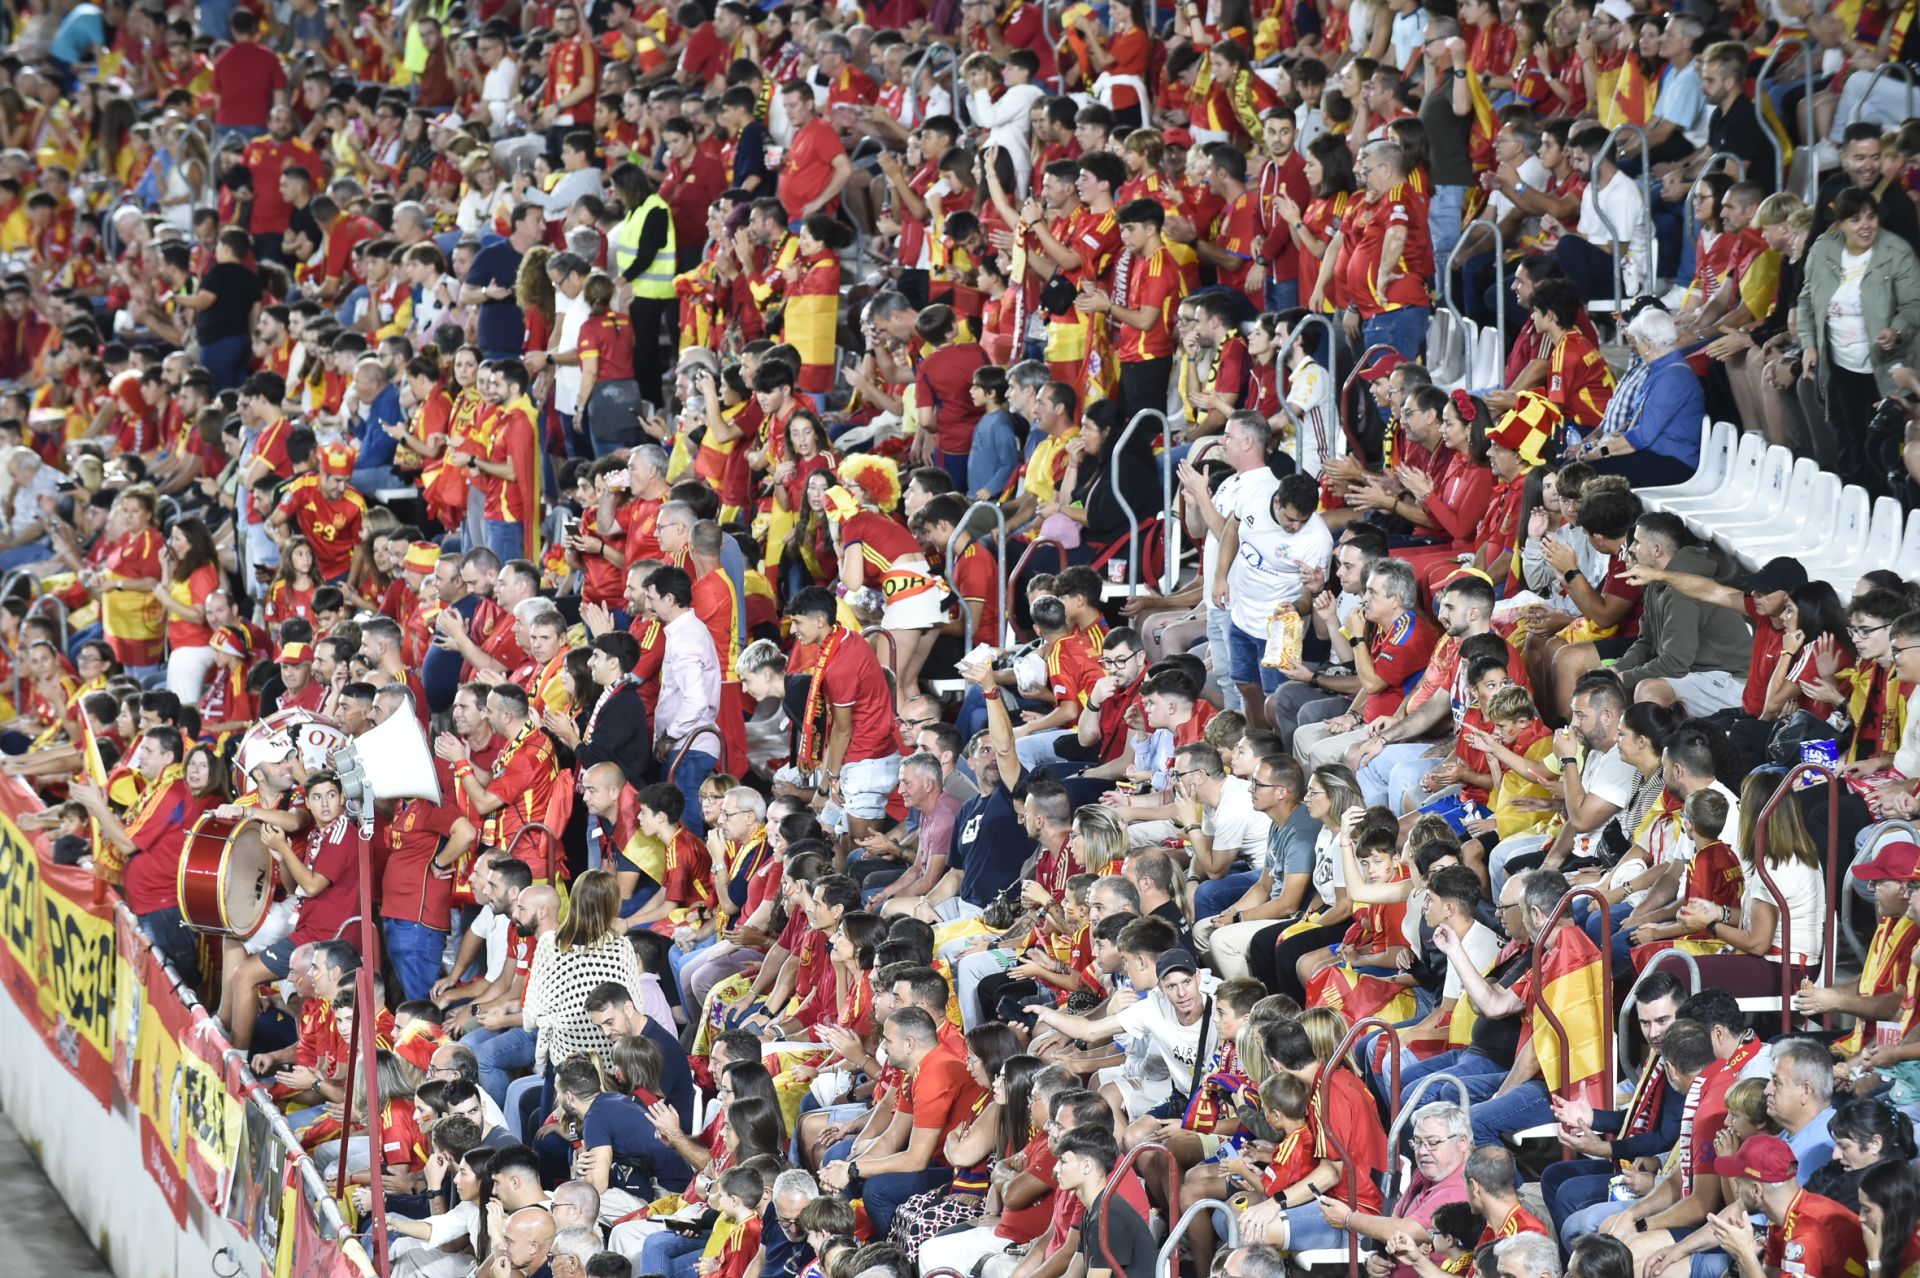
[1707,1134,1866,1278]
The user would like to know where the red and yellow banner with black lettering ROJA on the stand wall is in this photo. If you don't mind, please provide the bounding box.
[0,777,117,1105]
